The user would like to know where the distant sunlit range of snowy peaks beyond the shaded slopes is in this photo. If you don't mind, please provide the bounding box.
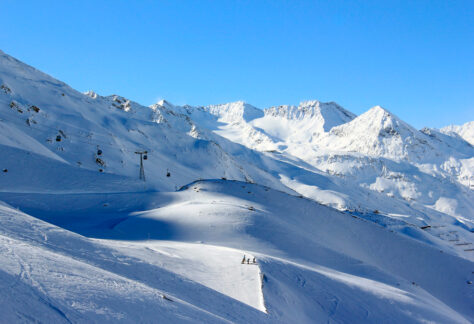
[153,97,474,239]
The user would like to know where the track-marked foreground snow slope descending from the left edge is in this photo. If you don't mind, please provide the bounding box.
[0,201,266,323]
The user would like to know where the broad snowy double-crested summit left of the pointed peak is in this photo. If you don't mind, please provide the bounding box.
[181,100,355,151]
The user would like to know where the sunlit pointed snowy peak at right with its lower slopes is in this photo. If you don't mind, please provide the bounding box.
[287,106,474,227]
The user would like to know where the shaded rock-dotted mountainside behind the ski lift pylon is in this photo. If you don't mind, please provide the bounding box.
[0,49,288,191]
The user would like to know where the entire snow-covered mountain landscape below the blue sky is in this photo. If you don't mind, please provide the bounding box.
[0,52,474,323]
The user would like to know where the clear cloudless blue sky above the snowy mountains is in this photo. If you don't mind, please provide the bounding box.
[0,0,474,128]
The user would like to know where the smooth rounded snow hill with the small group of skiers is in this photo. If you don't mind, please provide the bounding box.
[1,180,474,323]
